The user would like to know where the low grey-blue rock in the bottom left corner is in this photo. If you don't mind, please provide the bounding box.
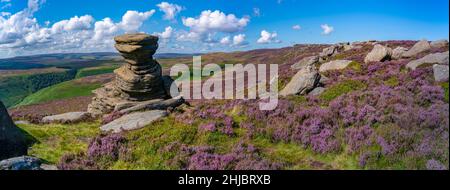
[0,156,41,170]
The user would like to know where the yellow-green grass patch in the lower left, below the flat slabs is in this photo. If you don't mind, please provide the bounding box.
[19,123,100,164]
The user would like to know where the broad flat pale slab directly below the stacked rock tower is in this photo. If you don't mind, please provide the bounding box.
[100,110,168,133]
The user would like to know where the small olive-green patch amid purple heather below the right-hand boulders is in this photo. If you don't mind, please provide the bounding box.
[319,80,367,102]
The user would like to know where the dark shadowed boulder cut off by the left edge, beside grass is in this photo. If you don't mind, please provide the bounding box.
[0,101,28,160]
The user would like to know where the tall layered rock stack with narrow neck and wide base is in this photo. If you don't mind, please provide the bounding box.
[88,33,181,116]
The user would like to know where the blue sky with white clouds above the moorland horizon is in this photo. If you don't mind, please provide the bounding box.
[0,0,449,58]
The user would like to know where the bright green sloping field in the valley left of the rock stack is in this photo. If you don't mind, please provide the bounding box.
[17,80,102,106]
